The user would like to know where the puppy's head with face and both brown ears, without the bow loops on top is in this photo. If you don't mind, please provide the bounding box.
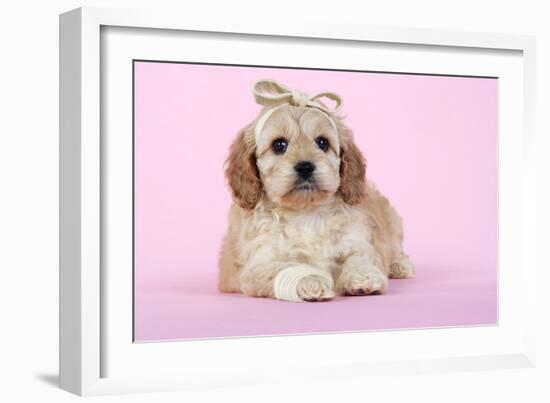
[226,80,365,209]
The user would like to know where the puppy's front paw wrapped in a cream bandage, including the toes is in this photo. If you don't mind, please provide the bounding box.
[274,265,335,302]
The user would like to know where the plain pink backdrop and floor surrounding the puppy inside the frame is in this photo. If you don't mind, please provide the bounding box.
[134,62,498,341]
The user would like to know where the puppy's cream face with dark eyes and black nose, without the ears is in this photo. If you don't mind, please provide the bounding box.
[256,105,340,208]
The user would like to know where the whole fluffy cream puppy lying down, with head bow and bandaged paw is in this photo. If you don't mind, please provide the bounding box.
[218,80,415,302]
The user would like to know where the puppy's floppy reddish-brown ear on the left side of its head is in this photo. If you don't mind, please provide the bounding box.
[225,126,262,209]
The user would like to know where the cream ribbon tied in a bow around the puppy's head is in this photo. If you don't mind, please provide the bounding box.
[252,80,342,143]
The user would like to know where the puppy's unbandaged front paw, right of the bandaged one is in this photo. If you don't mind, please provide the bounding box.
[336,267,388,295]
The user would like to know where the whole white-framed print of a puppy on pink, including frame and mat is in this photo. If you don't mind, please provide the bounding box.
[60,8,536,395]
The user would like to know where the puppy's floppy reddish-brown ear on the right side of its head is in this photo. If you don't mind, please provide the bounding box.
[338,125,366,205]
